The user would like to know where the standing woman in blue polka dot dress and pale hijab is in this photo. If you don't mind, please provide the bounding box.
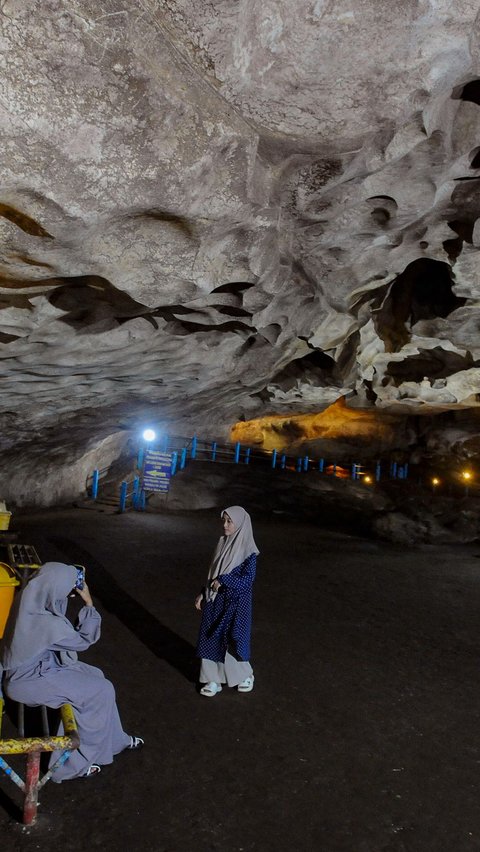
[195,506,259,698]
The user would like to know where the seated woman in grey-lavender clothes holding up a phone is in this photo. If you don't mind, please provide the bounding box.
[0,562,143,783]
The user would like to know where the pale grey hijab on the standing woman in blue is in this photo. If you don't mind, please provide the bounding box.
[206,506,260,600]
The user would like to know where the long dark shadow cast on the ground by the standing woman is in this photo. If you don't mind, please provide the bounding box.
[49,536,198,683]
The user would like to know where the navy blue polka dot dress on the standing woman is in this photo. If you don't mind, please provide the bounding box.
[197,553,257,663]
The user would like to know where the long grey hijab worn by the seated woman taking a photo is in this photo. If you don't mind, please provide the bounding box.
[0,562,77,669]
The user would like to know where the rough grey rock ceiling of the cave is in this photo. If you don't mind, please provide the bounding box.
[0,0,480,462]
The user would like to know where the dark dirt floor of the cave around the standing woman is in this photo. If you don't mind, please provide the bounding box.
[0,508,480,852]
